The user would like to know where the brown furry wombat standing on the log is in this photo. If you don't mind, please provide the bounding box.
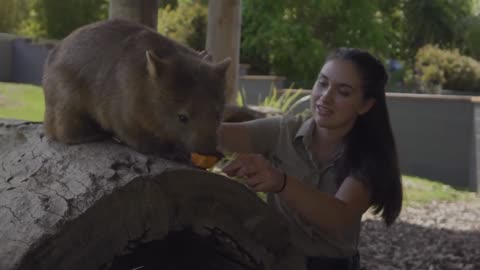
[43,20,230,160]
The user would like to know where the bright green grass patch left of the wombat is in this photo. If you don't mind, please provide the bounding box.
[0,82,45,121]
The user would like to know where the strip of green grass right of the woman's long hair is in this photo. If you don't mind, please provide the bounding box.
[402,175,478,205]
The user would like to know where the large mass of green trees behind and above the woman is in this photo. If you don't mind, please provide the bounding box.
[241,0,480,88]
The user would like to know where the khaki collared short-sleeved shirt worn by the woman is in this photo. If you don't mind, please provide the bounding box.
[249,117,360,257]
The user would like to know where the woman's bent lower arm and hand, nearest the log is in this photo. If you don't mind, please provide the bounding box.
[223,154,370,233]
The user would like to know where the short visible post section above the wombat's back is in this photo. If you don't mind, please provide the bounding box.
[108,0,159,29]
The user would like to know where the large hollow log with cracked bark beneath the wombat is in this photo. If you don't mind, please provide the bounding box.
[0,120,303,270]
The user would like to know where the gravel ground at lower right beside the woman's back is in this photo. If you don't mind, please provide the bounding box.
[360,199,480,270]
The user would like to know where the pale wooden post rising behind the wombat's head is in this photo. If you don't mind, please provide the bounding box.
[206,0,242,104]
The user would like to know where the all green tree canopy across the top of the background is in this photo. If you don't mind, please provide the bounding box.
[0,0,480,88]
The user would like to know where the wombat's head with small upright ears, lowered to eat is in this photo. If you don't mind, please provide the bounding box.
[140,51,231,154]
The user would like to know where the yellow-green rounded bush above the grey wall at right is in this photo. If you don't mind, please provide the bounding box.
[415,45,480,92]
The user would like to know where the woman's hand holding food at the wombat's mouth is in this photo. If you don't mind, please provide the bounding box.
[223,154,285,192]
